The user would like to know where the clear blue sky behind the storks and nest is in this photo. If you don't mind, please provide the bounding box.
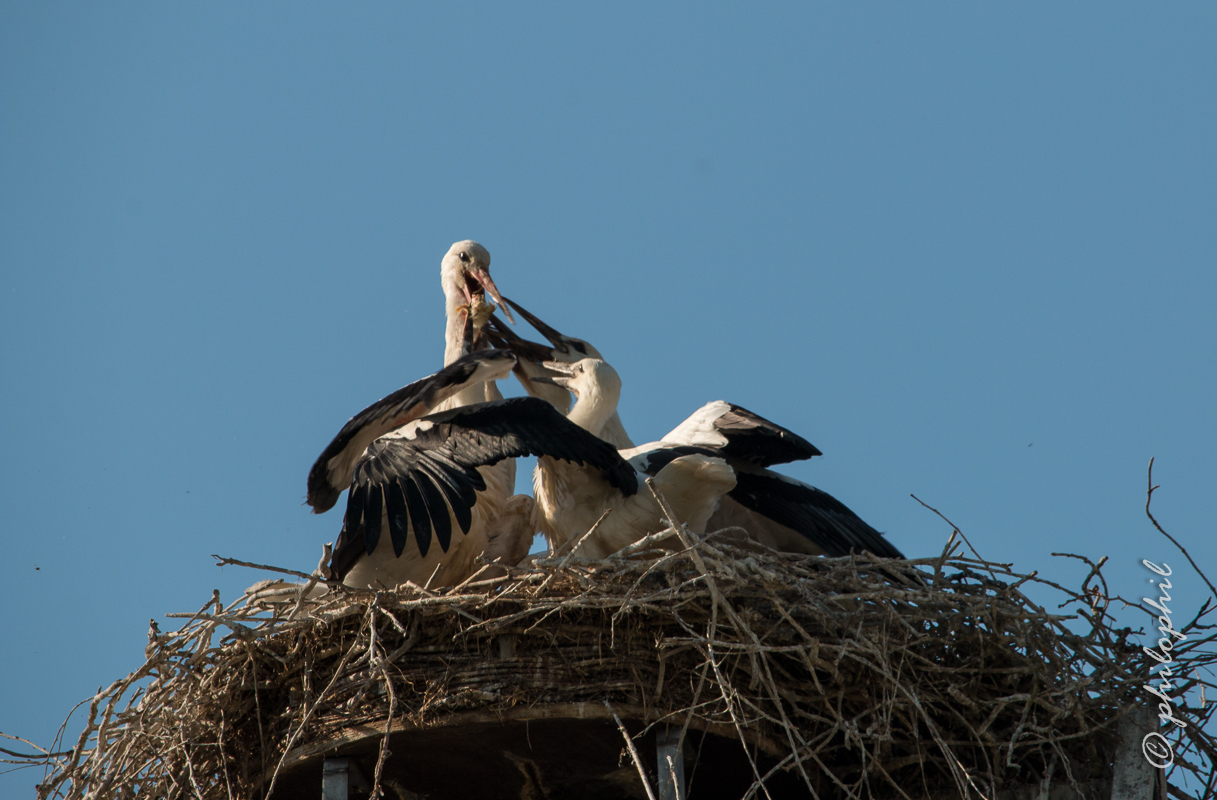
[0,2,1217,796]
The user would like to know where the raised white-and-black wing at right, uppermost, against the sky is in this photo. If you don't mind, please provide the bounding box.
[663,401,821,466]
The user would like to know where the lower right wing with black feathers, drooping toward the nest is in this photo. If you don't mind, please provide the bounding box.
[730,470,904,559]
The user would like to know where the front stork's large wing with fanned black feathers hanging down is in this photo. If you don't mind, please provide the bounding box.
[331,397,638,577]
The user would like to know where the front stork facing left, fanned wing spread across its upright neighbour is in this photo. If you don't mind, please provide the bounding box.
[332,359,735,567]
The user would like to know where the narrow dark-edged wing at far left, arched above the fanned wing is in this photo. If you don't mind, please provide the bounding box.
[308,349,516,514]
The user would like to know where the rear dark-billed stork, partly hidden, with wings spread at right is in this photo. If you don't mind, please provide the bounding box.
[487,298,903,558]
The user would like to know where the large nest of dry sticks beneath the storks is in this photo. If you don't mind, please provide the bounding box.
[23,521,1212,798]
